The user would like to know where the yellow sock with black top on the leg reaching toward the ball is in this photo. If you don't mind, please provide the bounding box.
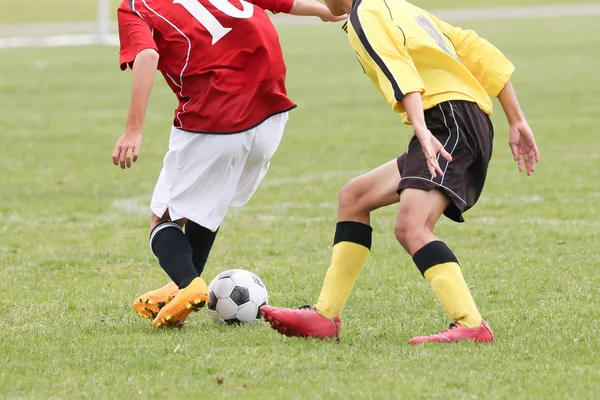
[315,221,373,318]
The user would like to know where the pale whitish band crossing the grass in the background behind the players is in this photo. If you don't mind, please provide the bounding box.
[0,4,600,49]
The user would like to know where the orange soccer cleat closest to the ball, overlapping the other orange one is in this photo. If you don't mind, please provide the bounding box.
[152,278,208,328]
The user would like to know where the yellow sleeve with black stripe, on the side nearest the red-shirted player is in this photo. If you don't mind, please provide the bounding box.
[349,7,425,113]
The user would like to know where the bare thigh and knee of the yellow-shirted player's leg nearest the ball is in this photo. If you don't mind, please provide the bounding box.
[339,159,400,212]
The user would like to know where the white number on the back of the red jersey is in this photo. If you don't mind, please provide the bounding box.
[173,0,254,44]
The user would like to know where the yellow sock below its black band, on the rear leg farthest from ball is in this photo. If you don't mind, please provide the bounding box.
[424,262,481,328]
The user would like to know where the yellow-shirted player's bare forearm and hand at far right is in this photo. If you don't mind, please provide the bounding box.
[498,81,540,175]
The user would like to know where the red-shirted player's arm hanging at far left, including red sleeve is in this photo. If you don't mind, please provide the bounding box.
[112,1,159,168]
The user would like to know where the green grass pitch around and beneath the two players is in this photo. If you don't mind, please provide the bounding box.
[0,3,600,399]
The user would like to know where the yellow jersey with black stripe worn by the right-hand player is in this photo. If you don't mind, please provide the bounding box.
[345,0,514,123]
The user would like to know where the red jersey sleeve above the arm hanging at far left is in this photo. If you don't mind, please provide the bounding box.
[117,0,158,71]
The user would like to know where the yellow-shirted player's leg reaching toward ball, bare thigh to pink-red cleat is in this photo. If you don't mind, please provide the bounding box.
[262,156,404,338]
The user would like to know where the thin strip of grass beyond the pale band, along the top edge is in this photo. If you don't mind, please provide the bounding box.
[0,0,598,24]
